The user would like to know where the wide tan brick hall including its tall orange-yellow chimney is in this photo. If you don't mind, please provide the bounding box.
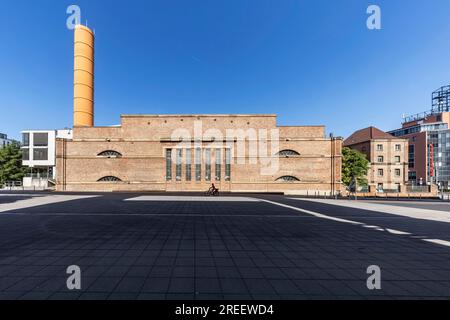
[56,26,342,194]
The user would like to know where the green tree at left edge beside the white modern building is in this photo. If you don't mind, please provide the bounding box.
[0,143,26,185]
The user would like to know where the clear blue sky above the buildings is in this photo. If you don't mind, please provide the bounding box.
[0,0,450,137]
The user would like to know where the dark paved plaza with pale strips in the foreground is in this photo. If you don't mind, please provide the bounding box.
[0,193,450,300]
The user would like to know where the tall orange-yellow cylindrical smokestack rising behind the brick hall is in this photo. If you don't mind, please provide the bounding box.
[73,25,95,127]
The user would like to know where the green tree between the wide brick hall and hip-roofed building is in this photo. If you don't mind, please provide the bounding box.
[342,148,369,186]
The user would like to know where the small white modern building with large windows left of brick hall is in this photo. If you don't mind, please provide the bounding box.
[22,129,72,188]
